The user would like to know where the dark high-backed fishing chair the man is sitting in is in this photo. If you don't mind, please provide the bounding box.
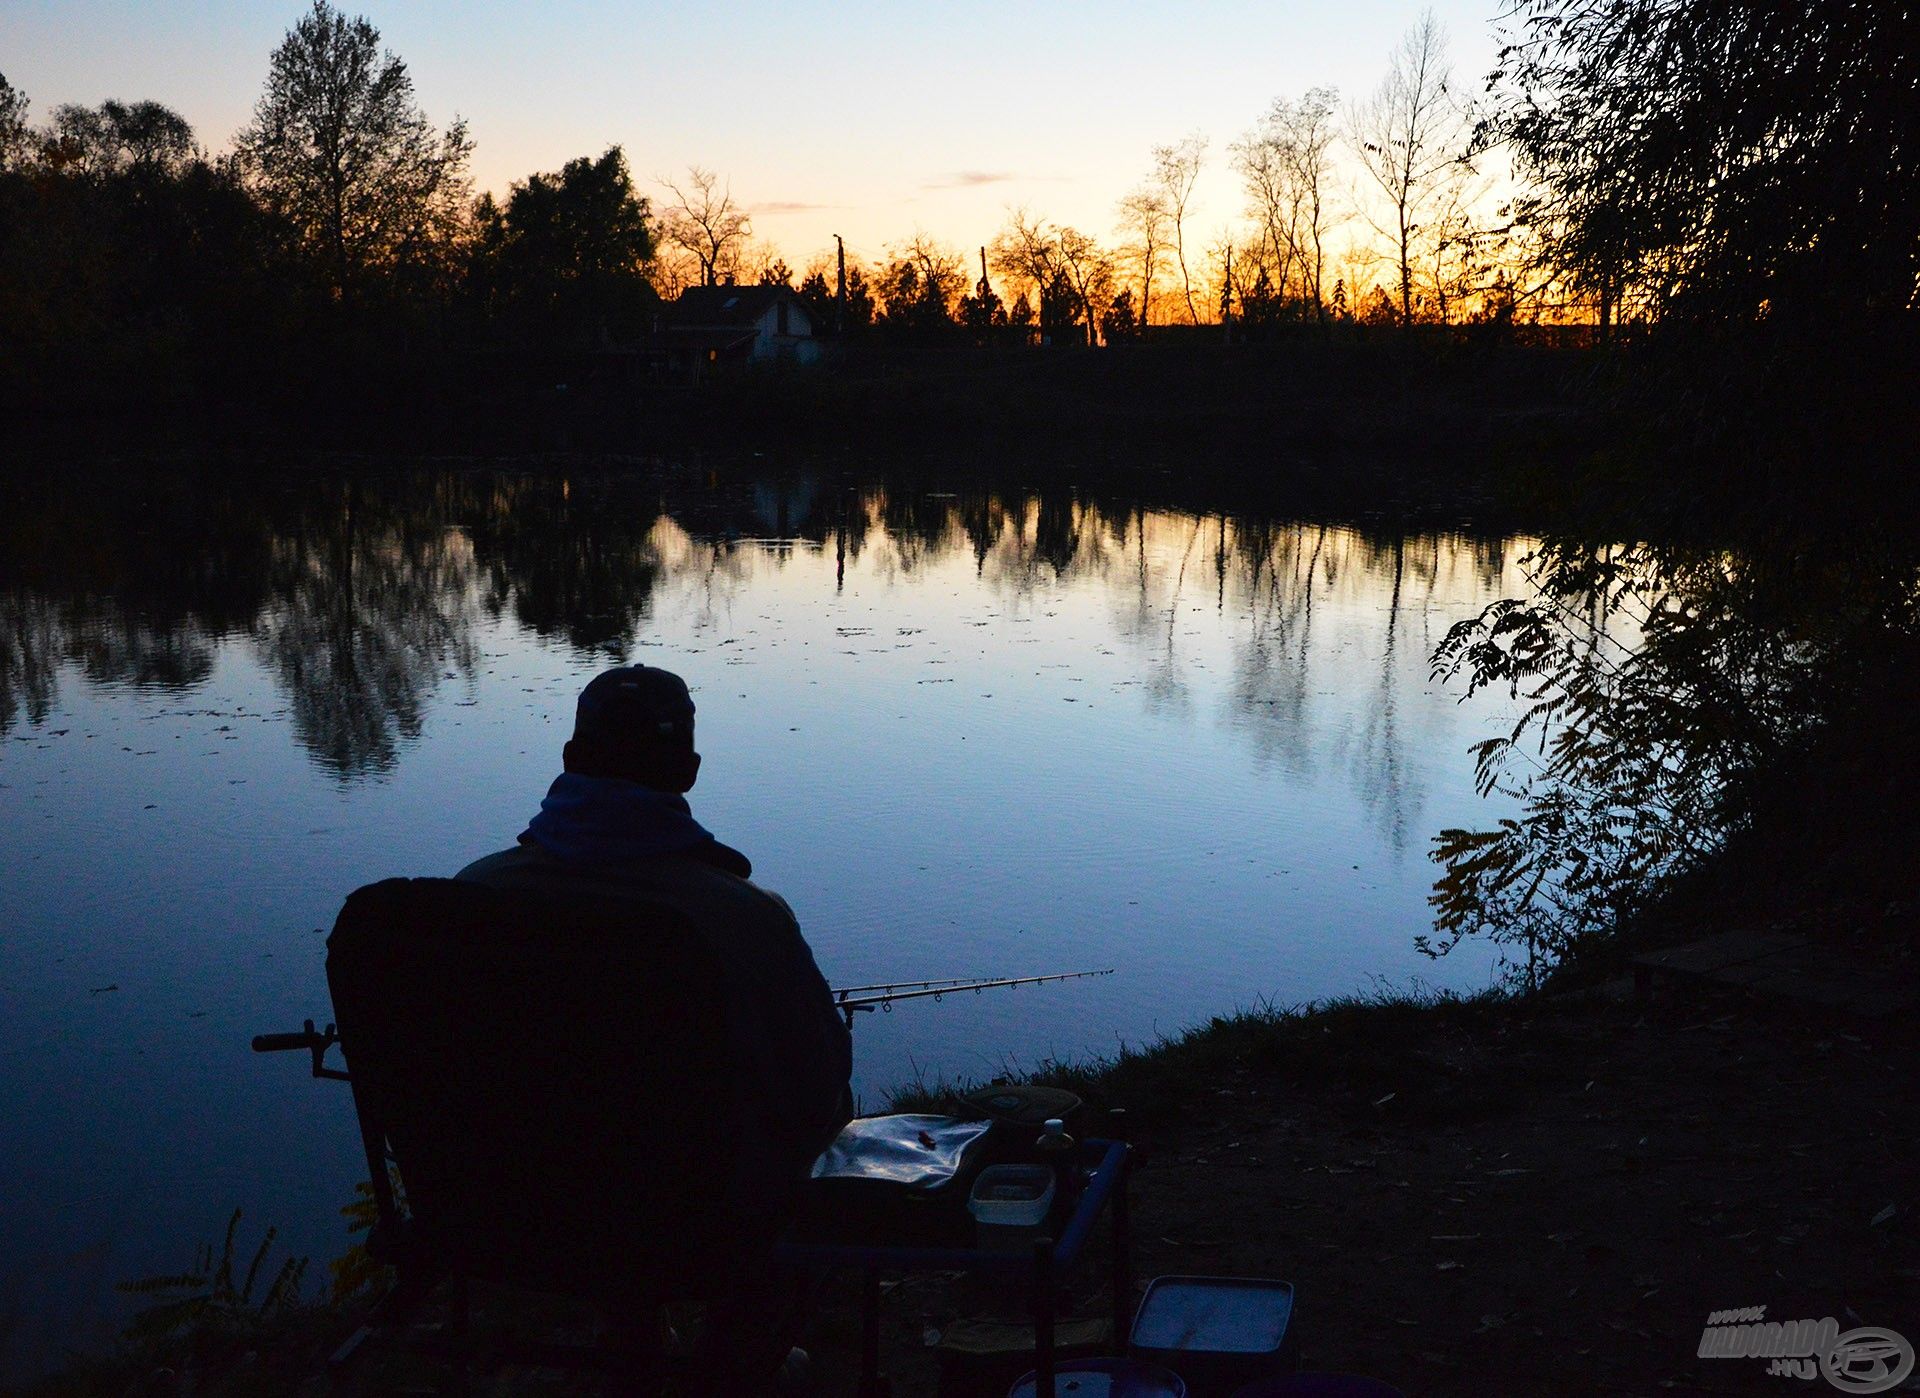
[297,880,772,1373]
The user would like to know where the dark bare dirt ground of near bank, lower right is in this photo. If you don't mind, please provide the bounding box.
[814,991,1920,1398]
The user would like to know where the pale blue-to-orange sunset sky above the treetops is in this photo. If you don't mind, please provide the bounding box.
[0,0,1501,265]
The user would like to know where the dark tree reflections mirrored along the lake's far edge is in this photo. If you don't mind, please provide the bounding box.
[0,469,1509,814]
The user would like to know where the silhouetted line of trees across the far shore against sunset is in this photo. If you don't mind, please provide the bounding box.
[0,0,1920,458]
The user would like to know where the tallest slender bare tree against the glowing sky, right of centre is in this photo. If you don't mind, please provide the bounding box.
[1350,10,1469,325]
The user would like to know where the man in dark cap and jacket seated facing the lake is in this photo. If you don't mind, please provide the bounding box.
[455,664,852,1390]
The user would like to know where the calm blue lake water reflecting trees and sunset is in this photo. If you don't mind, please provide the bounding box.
[0,463,1524,1373]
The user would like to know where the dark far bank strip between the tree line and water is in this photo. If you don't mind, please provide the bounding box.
[0,337,1603,503]
